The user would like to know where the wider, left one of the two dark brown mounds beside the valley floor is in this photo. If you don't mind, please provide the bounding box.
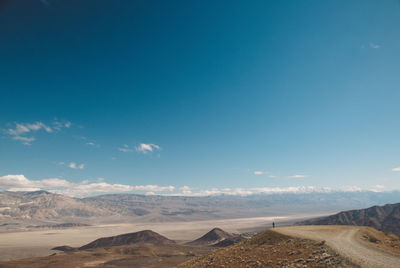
[79,230,175,250]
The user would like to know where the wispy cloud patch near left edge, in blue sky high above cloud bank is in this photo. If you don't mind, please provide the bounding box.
[3,120,71,145]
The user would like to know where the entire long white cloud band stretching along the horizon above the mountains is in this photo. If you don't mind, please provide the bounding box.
[0,175,385,196]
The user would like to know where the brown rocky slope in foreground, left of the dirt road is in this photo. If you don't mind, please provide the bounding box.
[178,230,349,268]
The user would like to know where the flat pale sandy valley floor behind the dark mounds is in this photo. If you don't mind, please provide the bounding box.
[0,215,317,261]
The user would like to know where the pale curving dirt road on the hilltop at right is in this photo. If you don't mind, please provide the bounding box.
[275,226,400,268]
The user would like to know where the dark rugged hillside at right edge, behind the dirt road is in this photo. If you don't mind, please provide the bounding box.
[298,203,400,235]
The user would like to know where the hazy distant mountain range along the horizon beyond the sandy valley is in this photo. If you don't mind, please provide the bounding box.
[0,191,400,231]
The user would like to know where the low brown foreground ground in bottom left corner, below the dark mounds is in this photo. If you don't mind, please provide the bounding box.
[0,244,213,268]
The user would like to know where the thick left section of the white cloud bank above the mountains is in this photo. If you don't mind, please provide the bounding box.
[0,175,175,196]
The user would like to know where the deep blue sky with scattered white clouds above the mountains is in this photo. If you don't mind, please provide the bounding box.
[0,0,400,196]
